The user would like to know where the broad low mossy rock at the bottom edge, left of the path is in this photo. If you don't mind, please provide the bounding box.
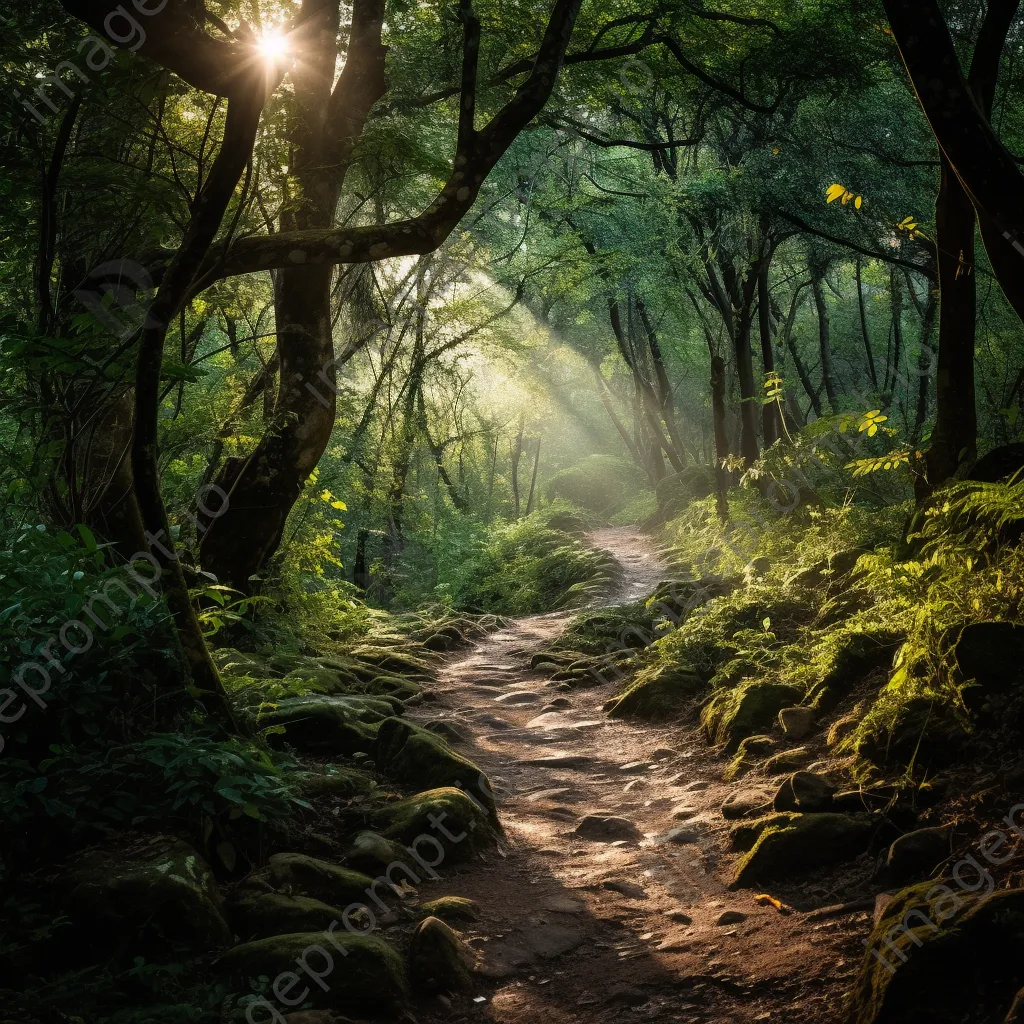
[216,928,407,1019]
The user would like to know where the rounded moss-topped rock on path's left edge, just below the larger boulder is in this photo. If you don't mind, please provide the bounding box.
[372,786,496,860]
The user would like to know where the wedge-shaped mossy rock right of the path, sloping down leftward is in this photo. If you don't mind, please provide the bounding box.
[731,814,877,889]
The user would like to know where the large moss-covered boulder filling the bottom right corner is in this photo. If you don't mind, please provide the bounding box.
[850,884,1024,1024]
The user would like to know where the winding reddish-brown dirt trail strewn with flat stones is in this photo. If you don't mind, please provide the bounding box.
[411,528,866,1024]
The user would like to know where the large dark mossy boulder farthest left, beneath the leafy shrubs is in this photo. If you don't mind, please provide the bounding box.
[65,836,231,954]
